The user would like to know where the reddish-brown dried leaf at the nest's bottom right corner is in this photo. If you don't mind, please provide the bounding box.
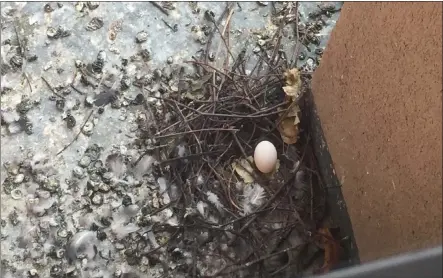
[317,228,340,273]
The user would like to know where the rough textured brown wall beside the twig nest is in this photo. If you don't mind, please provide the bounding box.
[313,2,442,261]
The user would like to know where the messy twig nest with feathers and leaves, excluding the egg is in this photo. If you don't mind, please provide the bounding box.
[132,15,332,277]
